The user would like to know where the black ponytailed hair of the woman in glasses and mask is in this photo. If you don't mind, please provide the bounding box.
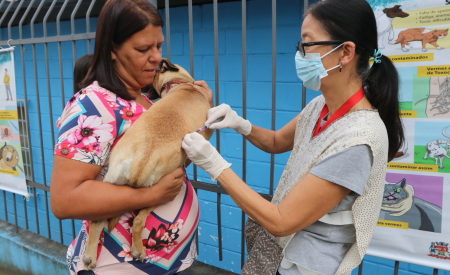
[304,0,405,161]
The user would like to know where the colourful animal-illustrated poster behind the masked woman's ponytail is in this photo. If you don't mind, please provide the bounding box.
[367,0,450,270]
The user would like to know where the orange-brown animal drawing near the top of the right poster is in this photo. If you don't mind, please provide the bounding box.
[394,28,448,52]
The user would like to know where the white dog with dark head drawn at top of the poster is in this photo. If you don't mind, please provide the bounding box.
[376,5,409,49]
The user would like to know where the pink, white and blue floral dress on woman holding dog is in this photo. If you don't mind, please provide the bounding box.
[54,82,199,275]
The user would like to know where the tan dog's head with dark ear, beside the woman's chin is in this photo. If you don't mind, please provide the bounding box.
[149,58,194,96]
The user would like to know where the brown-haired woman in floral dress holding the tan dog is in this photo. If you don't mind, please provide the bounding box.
[51,0,206,275]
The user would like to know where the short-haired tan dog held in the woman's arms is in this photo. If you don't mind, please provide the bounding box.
[83,59,212,269]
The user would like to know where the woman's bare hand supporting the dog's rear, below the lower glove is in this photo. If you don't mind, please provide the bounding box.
[150,167,185,205]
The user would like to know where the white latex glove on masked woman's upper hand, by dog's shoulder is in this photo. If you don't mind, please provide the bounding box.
[205,104,252,136]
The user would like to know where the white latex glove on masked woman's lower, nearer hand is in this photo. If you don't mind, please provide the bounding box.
[181,132,231,181]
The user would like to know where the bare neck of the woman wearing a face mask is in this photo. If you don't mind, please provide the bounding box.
[322,78,362,117]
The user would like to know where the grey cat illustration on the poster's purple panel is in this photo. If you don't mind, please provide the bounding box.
[379,179,442,232]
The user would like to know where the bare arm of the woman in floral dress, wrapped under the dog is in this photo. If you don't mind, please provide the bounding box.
[50,156,184,220]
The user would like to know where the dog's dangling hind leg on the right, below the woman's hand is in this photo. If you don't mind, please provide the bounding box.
[131,207,155,262]
